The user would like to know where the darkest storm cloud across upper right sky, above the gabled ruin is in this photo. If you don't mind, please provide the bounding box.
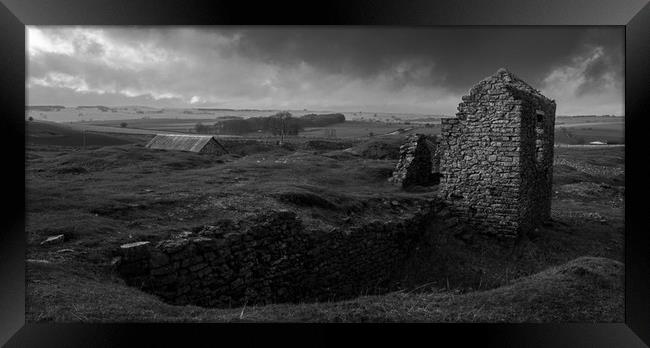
[227,27,622,90]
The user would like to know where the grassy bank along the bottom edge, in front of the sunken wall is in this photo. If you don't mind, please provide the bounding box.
[26,257,624,323]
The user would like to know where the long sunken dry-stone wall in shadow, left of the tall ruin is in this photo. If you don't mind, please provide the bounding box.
[116,201,443,307]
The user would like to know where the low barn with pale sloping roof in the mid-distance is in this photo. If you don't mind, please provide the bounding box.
[147,134,228,154]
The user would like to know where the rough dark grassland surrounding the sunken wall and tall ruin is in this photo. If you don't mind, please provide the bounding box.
[26,129,624,322]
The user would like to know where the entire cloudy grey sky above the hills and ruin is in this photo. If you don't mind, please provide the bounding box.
[27,26,624,115]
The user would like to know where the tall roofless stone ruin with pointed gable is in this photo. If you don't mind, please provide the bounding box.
[439,69,555,238]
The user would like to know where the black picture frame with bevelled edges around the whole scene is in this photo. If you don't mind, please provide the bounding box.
[0,0,650,347]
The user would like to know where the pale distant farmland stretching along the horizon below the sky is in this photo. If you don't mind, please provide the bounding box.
[28,106,625,145]
